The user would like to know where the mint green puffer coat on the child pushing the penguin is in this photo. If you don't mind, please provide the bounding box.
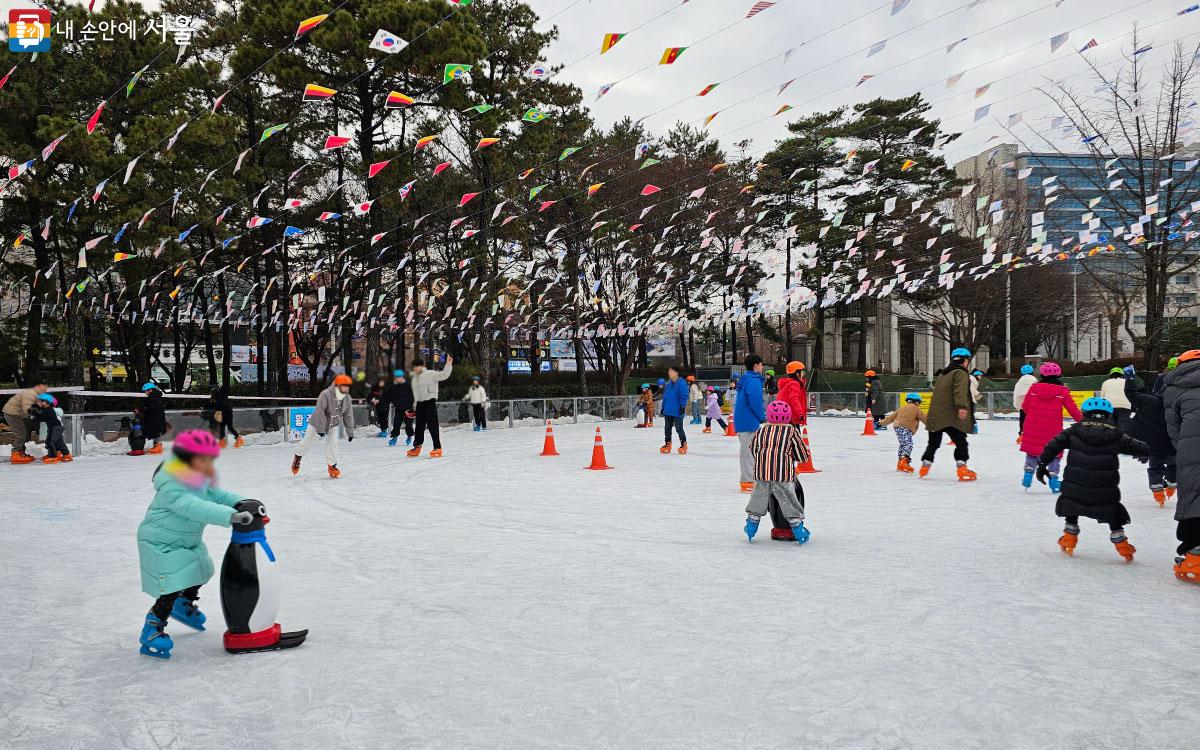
[138,458,245,598]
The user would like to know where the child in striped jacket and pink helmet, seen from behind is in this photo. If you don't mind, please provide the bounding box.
[743,401,811,545]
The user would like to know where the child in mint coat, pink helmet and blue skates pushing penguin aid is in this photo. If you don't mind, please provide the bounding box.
[138,430,253,659]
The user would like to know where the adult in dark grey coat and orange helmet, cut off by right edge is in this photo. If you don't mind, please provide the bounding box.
[1163,349,1200,583]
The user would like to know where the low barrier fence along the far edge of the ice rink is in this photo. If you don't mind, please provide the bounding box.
[23,391,1046,456]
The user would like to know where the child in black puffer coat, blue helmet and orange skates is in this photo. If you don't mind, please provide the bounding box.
[1036,396,1150,563]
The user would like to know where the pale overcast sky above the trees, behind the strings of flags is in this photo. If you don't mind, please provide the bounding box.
[542,0,1200,162]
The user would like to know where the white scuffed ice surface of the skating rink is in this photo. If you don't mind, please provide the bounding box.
[0,419,1200,749]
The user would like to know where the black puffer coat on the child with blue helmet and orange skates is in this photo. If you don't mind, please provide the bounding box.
[1038,416,1150,524]
